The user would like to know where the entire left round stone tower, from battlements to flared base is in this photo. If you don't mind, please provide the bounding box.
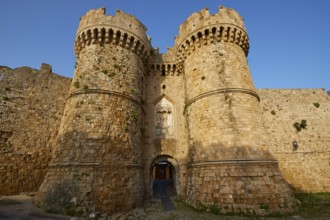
[37,8,150,213]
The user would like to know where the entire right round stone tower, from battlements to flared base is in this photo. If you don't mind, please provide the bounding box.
[176,7,295,215]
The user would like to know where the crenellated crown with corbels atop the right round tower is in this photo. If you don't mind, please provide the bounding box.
[175,6,249,62]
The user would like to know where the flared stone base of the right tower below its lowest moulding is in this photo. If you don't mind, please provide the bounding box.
[187,161,296,215]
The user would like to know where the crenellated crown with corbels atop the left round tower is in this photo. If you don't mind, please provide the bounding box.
[75,8,151,63]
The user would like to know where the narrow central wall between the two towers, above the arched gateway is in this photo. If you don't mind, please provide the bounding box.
[143,49,188,198]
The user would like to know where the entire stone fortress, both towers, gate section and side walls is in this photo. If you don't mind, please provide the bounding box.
[0,7,330,216]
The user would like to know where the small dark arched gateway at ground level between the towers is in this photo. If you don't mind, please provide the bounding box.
[150,155,180,195]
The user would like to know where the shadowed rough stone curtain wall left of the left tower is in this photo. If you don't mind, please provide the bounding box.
[0,64,71,195]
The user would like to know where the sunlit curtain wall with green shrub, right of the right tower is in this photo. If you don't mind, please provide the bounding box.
[258,89,330,192]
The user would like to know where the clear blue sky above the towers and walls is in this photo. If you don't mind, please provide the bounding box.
[0,0,330,90]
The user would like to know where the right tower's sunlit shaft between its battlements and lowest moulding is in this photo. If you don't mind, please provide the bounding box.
[185,43,268,161]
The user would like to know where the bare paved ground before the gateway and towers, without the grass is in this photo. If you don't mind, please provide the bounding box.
[0,193,329,220]
